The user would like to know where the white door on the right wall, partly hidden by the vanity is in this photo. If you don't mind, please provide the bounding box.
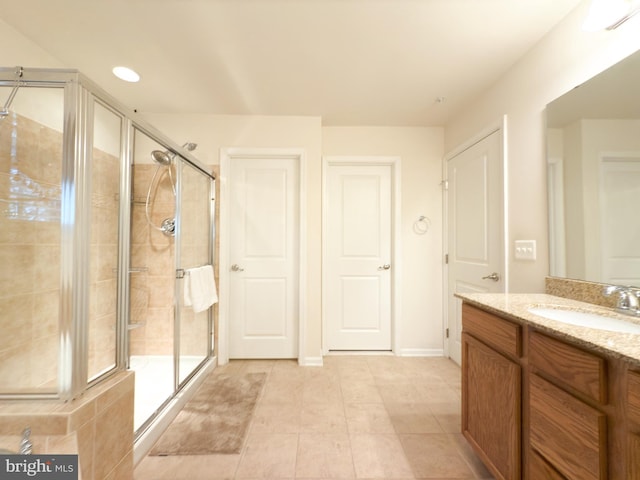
[447,131,505,363]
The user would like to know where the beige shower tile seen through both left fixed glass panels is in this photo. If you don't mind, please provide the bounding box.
[0,113,119,393]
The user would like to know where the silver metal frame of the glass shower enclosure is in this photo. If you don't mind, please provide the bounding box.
[0,67,215,400]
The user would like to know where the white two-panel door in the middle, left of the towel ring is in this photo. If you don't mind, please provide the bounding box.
[324,164,393,350]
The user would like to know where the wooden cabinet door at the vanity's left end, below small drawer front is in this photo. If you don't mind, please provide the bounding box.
[462,333,522,480]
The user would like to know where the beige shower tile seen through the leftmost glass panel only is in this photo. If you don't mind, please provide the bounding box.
[0,113,62,392]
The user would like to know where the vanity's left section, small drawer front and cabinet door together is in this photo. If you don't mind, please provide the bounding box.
[462,304,522,480]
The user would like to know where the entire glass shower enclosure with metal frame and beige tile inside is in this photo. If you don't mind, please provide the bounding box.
[0,67,215,438]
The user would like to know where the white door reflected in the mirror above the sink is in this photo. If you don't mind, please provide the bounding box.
[600,157,640,285]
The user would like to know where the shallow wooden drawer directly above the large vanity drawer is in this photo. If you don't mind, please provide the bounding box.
[529,331,607,405]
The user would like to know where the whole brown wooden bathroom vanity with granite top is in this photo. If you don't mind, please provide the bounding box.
[457,294,640,480]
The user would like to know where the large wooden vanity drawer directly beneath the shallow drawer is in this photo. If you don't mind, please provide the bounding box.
[529,374,607,480]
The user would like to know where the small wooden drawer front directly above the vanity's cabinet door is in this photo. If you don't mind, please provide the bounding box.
[462,303,522,357]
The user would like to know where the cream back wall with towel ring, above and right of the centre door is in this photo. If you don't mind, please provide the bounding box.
[322,127,444,355]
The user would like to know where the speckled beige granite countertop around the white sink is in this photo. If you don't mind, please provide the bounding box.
[455,293,640,367]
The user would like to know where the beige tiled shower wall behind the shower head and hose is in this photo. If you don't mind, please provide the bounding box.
[129,164,218,356]
